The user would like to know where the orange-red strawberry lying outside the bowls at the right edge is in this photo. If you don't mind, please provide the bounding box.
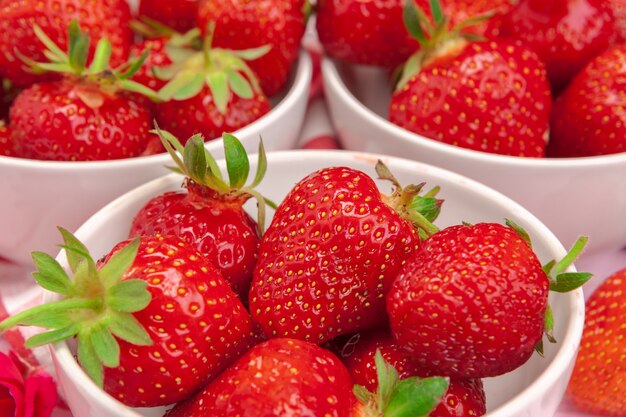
[567,269,626,416]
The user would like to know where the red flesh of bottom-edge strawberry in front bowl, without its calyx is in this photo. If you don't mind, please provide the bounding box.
[166,338,355,417]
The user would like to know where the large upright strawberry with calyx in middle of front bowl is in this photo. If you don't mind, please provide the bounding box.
[250,162,438,343]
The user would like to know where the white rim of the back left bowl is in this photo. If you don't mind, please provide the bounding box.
[0,49,313,172]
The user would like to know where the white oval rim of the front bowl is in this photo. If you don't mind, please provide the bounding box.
[44,149,585,417]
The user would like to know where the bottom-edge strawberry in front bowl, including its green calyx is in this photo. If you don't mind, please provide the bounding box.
[165,338,447,417]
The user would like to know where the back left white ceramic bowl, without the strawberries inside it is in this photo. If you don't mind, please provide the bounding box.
[0,51,312,264]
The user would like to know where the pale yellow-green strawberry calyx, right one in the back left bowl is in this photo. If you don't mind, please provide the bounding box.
[153,23,271,114]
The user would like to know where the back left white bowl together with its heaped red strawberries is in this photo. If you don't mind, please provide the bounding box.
[0,0,312,264]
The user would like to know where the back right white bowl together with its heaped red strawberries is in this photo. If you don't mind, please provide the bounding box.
[317,0,626,252]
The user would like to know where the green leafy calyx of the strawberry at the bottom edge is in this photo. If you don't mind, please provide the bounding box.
[354,349,449,417]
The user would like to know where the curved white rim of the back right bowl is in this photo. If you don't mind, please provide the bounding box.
[321,57,626,169]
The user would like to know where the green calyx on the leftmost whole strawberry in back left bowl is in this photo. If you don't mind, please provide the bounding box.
[16,19,158,107]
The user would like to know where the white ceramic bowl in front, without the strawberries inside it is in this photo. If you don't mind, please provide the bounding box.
[46,150,584,417]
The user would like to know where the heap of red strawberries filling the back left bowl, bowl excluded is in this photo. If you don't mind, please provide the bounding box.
[0,0,308,161]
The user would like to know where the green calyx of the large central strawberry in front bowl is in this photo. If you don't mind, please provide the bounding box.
[375,160,443,239]
